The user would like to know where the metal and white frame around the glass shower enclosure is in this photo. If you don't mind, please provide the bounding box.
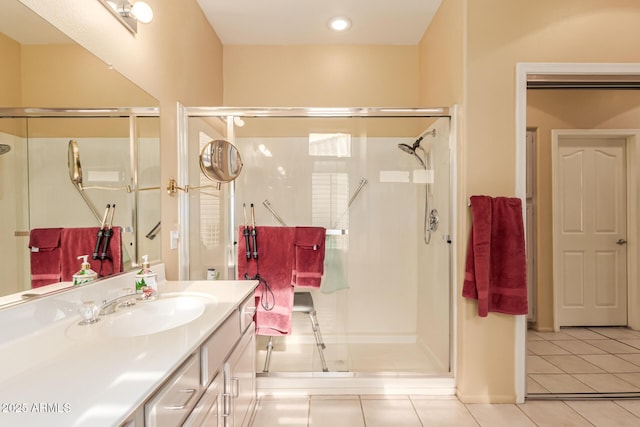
[177,104,458,396]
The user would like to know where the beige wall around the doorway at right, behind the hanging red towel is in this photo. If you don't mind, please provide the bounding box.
[444,0,640,402]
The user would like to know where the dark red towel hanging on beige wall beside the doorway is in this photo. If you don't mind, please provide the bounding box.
[462,196,528,317]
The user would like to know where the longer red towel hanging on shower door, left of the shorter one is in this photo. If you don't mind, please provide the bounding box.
[238,227,295,335]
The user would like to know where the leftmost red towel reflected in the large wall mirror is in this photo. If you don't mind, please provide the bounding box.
[29,228,62,288]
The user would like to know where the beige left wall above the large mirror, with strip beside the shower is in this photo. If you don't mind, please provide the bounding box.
[20,0,222,279]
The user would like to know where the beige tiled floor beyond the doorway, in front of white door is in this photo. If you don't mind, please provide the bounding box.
[527,327,640,397]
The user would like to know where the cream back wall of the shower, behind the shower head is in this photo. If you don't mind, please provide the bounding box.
[236,138,421,342]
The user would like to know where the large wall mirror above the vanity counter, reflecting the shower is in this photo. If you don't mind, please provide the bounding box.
[0,0,161,306]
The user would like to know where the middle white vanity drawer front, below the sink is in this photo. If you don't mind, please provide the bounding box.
[200,310,241,386]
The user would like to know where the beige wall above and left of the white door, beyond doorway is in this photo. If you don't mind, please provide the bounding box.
[527,90,640,331]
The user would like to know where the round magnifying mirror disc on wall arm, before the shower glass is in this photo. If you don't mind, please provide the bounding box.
[200,139,242,182]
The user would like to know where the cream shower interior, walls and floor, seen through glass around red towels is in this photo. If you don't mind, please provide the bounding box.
[234,114,452,374]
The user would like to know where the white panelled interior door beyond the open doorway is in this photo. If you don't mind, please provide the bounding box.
[553,136,627,326]
